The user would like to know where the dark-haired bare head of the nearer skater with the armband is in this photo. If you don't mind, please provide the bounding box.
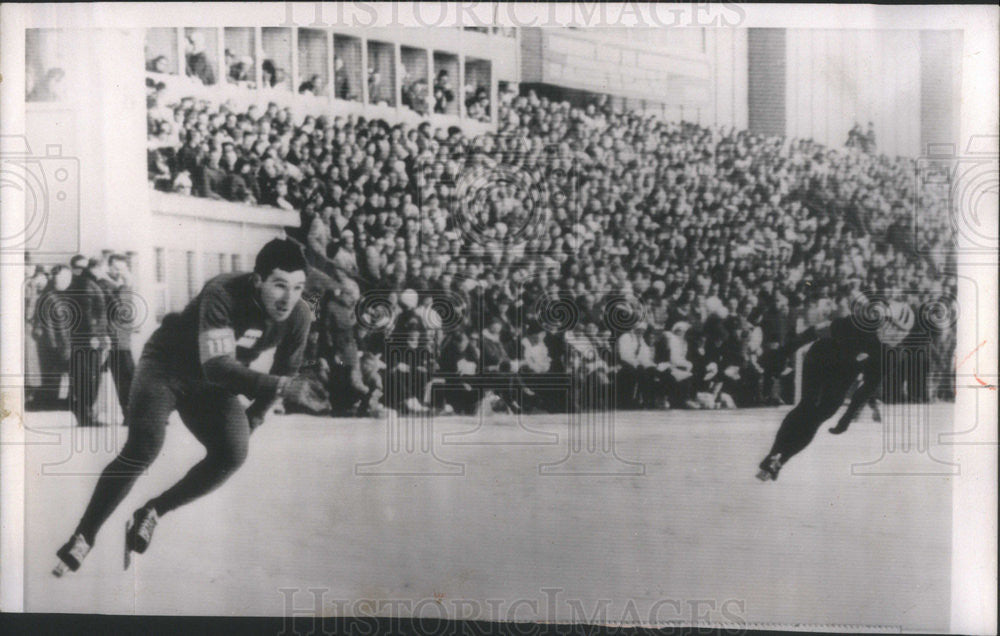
[253,239,306,322]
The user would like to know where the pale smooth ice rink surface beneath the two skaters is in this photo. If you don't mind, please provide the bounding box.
[25,404,953,631]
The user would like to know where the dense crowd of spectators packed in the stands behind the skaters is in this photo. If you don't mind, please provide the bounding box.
[149,78,955,412]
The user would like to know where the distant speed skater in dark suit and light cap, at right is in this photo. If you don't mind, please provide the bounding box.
[757,301,914,481]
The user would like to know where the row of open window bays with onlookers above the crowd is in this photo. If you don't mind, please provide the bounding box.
[146,27,493,115]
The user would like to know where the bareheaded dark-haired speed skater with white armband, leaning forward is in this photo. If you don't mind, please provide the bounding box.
[53,239,320,576]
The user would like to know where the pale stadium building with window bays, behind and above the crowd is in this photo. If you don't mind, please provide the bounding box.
[15,18,961,342]
